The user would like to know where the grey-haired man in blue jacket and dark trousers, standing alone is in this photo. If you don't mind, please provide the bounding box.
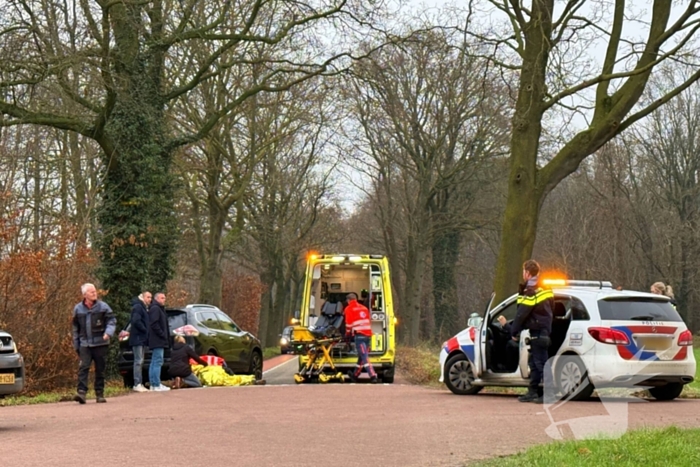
[73,284,117,404]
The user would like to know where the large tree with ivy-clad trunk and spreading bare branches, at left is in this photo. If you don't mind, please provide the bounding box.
[0,0,378,322]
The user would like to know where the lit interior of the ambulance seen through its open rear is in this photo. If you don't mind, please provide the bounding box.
[306,263,387,355]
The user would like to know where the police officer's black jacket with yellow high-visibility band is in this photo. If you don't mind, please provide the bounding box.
[510,283,554,337]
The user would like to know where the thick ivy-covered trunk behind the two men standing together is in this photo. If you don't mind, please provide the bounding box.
[98,4,178,325]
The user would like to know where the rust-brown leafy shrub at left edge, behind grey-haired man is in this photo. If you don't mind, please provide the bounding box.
[0,218,94,393]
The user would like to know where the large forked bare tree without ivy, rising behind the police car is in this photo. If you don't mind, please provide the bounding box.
[470,0,700,304]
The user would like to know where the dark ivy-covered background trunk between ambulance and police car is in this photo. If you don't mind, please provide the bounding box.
[433,230,462,342]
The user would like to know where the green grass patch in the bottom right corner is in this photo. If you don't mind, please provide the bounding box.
[467,427,700,467]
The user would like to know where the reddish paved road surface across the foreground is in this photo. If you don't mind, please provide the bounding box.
[0,362,700,467]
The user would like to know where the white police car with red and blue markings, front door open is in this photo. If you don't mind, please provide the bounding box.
[440,279,696,400]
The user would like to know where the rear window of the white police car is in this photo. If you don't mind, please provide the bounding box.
[598,297,683,321]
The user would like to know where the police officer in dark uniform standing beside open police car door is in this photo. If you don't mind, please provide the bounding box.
[510,259,554,403]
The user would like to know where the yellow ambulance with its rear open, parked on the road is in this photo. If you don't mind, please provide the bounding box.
[294,254,397,383]
